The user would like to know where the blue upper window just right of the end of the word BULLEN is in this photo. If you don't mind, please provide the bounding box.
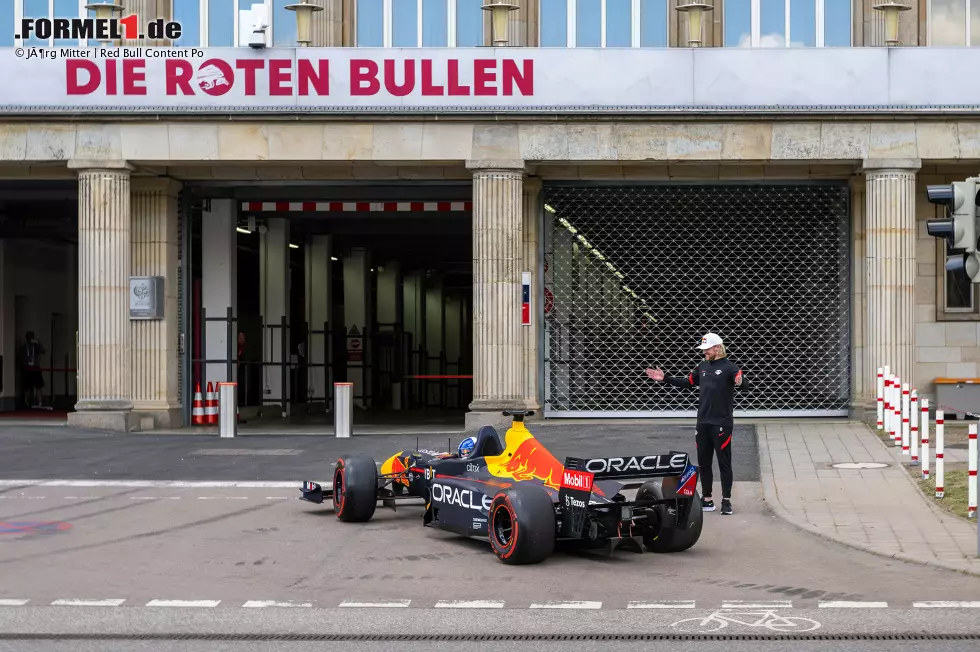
[538,0,668,48]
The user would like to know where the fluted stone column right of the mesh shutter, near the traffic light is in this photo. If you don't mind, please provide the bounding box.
[859,159,921,408]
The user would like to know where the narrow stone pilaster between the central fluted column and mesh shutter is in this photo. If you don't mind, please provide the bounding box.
[521,177,541,418]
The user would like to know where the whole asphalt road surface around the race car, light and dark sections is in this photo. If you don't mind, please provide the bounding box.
[0,427,980,652]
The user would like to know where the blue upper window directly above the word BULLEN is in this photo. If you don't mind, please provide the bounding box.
[355,0,486,48]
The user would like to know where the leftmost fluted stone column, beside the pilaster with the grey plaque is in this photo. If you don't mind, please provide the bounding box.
[68,161,135,431]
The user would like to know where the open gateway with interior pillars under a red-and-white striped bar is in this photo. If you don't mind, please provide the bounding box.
[187,184,473,428]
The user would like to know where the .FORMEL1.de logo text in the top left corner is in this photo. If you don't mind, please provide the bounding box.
[14,14,183,41]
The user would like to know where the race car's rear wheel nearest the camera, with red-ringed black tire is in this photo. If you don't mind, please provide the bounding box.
[487,484,557,565]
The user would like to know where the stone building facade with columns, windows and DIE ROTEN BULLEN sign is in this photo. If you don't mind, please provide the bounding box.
[0,0,980,430]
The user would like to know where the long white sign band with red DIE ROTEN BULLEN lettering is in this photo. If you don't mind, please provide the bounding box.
[0,47,980,115]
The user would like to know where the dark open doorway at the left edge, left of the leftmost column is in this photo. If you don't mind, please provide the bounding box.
[0,181,78,420]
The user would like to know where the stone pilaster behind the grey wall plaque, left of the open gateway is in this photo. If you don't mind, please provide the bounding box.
[131,179,181,428]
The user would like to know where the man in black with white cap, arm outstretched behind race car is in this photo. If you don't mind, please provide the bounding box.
[646,333,748,514]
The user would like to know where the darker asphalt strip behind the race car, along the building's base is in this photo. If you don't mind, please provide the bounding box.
[0,424,759,482]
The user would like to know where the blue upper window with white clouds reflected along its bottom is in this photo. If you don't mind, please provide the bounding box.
[723,0,848,48]
